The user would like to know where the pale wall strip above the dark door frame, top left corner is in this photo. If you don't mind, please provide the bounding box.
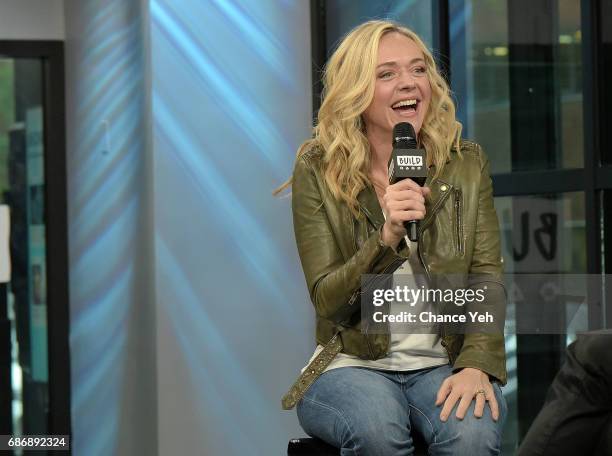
[0,0,65,40]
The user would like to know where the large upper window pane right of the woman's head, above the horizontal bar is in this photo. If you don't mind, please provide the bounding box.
[449,0,583,173]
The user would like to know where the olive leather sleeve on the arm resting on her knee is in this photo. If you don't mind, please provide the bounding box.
[453,146,507,384]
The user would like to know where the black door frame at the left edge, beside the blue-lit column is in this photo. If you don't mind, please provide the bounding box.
[0,40,71,442]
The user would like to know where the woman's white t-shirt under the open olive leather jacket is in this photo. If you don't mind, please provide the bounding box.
[302,237,448,372]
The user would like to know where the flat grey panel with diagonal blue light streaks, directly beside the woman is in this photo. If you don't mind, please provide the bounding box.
[150,0,314,455]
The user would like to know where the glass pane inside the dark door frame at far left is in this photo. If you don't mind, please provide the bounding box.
[0,57,49,435]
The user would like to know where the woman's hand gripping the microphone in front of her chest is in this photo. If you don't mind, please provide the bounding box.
[381,179,431,249]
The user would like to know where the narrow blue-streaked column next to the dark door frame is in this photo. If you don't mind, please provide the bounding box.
[66,0,149,456]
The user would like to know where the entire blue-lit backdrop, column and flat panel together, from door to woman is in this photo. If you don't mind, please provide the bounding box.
[65,0,314,456]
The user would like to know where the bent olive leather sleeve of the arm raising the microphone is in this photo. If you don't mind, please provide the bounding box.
[292,157,408,323]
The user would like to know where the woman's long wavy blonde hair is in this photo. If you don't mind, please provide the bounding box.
[275,20,462,214]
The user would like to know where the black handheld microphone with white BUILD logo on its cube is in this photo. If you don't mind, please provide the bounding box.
[389,122,427,242]
